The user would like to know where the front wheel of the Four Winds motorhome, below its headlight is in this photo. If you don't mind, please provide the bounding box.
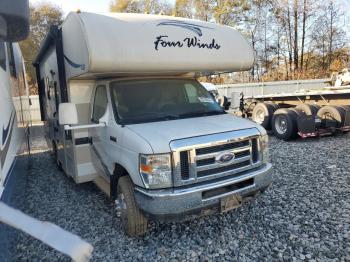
[116,176,148,236]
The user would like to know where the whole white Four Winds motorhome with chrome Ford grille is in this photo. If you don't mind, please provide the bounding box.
[35,12,271,235]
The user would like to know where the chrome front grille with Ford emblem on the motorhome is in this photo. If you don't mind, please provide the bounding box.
[178,137,260,185]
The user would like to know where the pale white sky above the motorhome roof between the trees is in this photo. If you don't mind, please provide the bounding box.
[29,0,175,14]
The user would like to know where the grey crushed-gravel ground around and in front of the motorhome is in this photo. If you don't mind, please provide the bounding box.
[14,127,350,261]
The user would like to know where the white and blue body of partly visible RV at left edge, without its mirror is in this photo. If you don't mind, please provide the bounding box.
[0,41,31,261]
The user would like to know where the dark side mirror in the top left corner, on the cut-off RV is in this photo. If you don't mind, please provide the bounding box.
[0,0,29,42]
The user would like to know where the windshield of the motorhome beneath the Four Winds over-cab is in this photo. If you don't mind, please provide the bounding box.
[110,79,225,124]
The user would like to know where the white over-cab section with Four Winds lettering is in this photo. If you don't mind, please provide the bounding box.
[62,13,254,79]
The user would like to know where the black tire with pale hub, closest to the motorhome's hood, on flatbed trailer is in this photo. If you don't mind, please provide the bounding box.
[272,108,298,141]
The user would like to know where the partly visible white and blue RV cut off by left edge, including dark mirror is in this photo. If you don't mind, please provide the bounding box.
[0,0,30,261]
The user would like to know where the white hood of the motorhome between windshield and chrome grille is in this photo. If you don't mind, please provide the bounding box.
[127,114,266,153]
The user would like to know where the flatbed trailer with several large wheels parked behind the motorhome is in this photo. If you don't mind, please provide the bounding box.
[217,69,350,140]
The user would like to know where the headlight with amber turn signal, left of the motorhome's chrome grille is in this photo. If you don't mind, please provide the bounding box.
[140,154,172,189]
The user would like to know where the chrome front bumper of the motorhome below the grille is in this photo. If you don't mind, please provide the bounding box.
[135,163,272,219]
